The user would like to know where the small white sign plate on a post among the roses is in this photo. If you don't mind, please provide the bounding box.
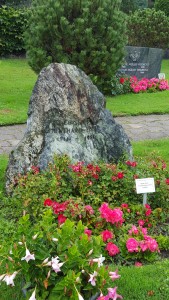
[135,178,155,194]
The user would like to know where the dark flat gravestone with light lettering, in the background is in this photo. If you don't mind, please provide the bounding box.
[119,46,163,79]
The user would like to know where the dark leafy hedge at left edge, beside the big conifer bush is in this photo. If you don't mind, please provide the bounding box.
[0,6,26,56]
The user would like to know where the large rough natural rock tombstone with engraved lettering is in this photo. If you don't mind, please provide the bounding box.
[6,63,131,191]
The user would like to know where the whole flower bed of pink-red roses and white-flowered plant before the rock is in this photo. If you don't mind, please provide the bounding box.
[0,156,169,299]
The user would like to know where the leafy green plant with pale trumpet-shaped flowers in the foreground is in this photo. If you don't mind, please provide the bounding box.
[0,209,123,300]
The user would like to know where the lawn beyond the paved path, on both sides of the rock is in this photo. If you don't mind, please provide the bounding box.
[0,59,169,125]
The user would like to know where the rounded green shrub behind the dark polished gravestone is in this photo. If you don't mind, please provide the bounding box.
[127,8,169,49]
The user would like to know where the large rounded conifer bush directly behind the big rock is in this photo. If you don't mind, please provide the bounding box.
[25,0,126,92]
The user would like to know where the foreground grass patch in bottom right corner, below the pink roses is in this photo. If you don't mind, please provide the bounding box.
[115,260,169,300]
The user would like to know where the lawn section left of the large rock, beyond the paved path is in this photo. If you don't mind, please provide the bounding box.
[0,59,37,125]
